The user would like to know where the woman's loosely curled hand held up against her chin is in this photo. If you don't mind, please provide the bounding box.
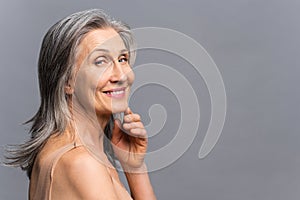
[111,108,148,169]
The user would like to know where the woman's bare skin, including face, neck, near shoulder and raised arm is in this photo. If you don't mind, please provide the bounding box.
[45,28,156,200]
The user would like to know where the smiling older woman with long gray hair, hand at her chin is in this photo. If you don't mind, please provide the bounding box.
[8,9,155,200]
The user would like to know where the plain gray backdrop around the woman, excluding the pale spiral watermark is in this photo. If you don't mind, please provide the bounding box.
[0,0,300,200]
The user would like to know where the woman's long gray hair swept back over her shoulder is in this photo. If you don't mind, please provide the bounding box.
[6,9,135,178]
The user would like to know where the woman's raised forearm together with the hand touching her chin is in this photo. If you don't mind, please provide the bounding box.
[111,108,156,200]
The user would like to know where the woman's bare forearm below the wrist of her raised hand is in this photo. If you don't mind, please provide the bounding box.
[125,165,156,200]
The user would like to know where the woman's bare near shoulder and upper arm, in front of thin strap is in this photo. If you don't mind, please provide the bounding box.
[52,147,117,199]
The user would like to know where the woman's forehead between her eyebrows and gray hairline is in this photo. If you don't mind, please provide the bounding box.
[77,28,125,59]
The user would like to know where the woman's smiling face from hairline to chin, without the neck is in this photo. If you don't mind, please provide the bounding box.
[72,28,134,116]
